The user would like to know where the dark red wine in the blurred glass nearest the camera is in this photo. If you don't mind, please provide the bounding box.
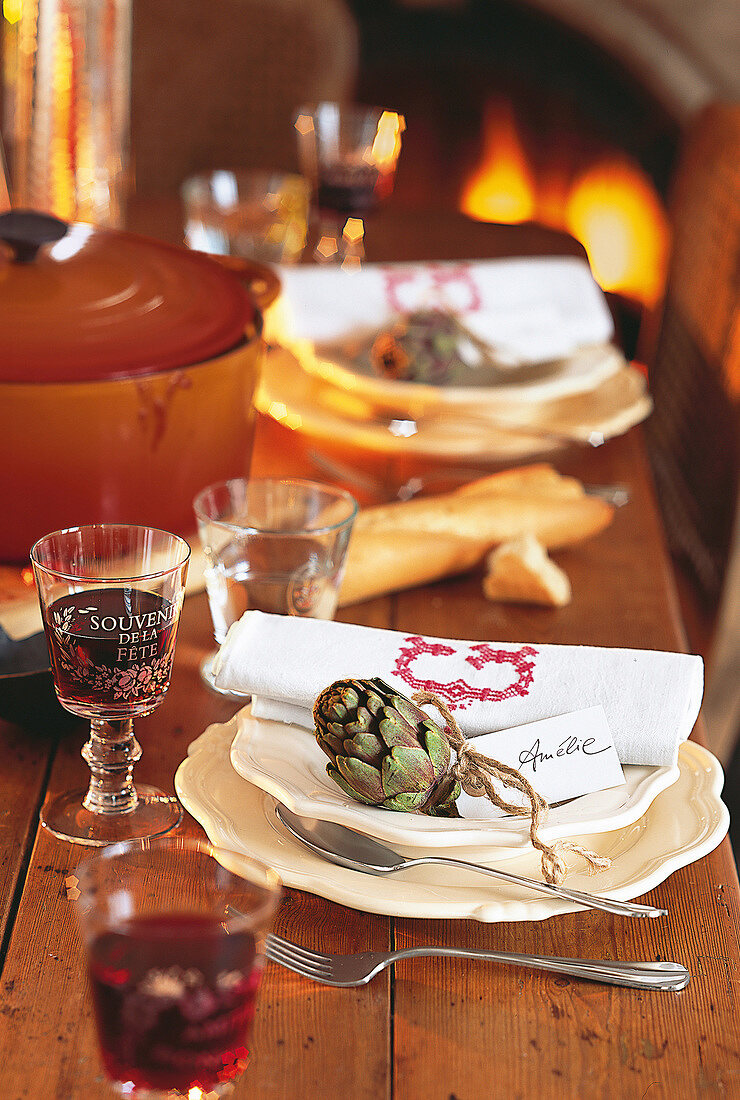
[89,913,262,1095]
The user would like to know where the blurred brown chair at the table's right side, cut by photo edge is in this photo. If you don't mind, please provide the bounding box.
[644,103,740,765]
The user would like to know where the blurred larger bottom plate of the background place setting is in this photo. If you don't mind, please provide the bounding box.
[255,348,652,461]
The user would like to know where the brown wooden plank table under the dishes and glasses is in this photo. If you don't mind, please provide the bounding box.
[0,206,740,1100]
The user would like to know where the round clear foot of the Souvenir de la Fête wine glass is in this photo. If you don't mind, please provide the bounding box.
[40,785,183,848]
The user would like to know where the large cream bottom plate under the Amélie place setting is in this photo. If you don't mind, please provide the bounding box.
[175,724,729,922]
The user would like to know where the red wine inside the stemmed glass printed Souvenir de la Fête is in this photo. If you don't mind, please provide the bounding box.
[44,586,177,721]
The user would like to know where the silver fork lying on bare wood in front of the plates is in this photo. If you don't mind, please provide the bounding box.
[265,934,691,992]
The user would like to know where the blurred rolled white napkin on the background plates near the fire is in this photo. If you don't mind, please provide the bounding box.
[273,256,614,363]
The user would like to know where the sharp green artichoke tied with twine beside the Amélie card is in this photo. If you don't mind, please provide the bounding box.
[313,679,460,817]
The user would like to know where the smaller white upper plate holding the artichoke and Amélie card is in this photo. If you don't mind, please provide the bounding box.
[225,706,678,858]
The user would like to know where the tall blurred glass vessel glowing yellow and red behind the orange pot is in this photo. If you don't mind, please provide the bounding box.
[3,0,131,227]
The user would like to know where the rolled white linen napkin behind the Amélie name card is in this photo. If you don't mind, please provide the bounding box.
[216,612,704,766]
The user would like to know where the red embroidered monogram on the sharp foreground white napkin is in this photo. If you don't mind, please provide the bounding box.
[394,635,538,711]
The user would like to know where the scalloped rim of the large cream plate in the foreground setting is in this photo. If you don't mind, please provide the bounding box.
[175,724,729,923]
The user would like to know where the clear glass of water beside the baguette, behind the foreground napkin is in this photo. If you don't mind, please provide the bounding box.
[194,477,357,686]
